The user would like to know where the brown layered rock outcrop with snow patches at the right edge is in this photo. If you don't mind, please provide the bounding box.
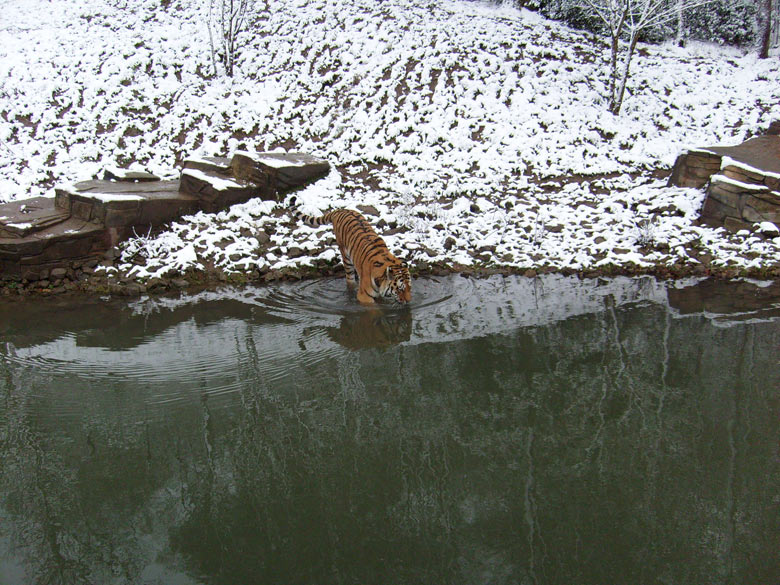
[669,135,780,231]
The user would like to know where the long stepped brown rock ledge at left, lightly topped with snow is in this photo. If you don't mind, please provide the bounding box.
[0,152,330,280]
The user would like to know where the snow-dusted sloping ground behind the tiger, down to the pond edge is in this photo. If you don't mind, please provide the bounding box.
[0,0,780,277]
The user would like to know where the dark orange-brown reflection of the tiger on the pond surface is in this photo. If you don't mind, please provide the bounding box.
[300,308,412,350]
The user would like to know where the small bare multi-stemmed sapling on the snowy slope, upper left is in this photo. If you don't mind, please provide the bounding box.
[208,0,254,77]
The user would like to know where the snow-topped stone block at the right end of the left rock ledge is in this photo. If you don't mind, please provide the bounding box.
[231,150,330,192]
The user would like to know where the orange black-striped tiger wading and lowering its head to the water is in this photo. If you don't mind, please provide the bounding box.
[295,203,412,305]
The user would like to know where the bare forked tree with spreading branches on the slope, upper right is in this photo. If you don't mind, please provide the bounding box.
[579,0,711,115]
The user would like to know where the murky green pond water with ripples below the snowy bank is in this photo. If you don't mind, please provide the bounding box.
[0,276,780,585]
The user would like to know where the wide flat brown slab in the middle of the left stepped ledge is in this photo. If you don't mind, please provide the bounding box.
[55,180,200,228]
